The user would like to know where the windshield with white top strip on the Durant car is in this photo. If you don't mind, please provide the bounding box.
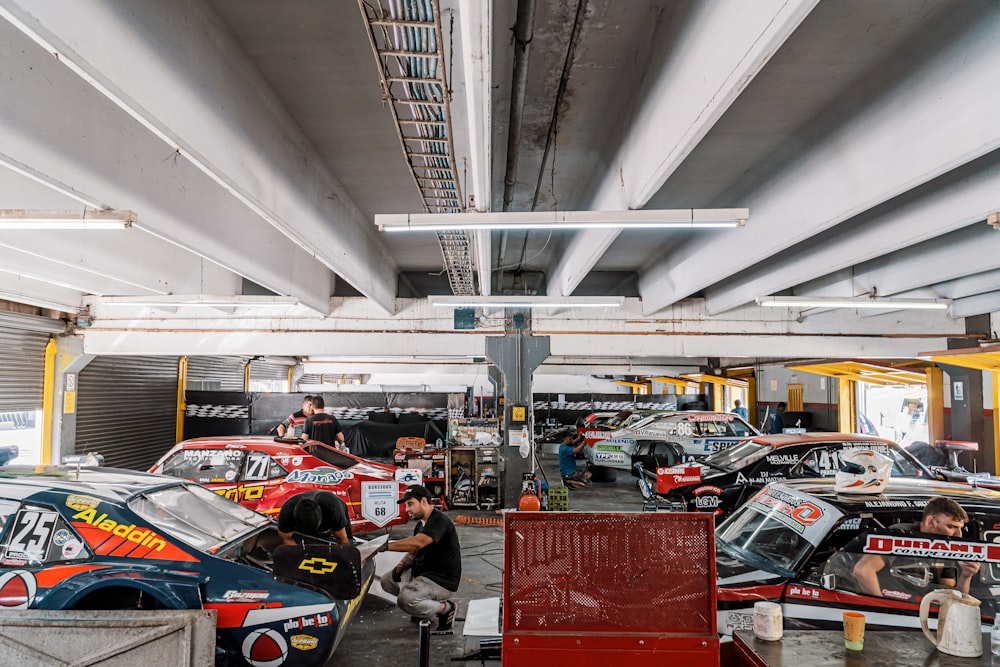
[715,487,843,577]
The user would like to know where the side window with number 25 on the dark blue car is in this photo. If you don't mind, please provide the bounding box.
[0,503,90,567]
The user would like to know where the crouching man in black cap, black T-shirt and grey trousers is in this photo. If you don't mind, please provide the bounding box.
[382,484,462,633]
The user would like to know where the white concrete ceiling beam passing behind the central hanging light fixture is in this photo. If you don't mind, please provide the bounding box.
[548,0,817,296]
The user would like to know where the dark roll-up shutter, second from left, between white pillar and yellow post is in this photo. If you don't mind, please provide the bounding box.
[76,357,178,470]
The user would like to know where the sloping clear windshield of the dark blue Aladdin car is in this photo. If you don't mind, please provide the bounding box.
[128,484,270,551]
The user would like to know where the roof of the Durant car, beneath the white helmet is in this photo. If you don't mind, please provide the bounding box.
[768,477,1000,514]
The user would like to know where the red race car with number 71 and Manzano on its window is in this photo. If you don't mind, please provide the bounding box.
[149,436,406,534]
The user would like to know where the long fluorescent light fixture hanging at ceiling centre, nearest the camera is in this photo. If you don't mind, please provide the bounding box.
[375,208,750,232]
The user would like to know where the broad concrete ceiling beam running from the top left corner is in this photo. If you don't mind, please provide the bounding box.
[0,0,396,312]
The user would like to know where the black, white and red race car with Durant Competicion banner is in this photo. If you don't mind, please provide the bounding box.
[715,477,1000,636]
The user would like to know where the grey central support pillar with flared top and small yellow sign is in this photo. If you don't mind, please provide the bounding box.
[486,332,549,508]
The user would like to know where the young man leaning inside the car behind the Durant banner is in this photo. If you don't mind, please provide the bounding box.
[853,496,979,597]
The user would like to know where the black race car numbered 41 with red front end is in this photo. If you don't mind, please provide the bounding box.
[632,433,934,521]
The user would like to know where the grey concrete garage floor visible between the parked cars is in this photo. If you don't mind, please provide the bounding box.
[329,454,642,667]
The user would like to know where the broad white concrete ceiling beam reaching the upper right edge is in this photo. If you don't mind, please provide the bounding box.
[639,5,1000,313]
